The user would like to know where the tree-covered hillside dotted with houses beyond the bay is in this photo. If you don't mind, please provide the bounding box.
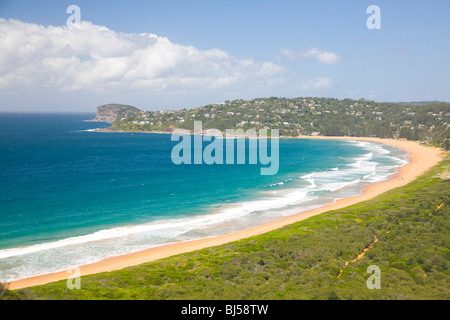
[97,97,450,150]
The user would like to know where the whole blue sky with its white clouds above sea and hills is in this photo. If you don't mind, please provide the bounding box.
[0,0,450,111]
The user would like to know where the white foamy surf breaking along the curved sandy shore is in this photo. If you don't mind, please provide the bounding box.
[0,141,408,281]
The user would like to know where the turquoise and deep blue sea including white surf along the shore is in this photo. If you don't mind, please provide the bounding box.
[0,113,407,282]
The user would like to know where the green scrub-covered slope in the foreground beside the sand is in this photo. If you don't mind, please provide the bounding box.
[18,156,450,299]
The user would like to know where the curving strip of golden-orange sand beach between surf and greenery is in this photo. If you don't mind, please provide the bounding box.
[9,136,444,290]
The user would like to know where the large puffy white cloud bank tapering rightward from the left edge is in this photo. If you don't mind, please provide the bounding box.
[0,19,285,91]
